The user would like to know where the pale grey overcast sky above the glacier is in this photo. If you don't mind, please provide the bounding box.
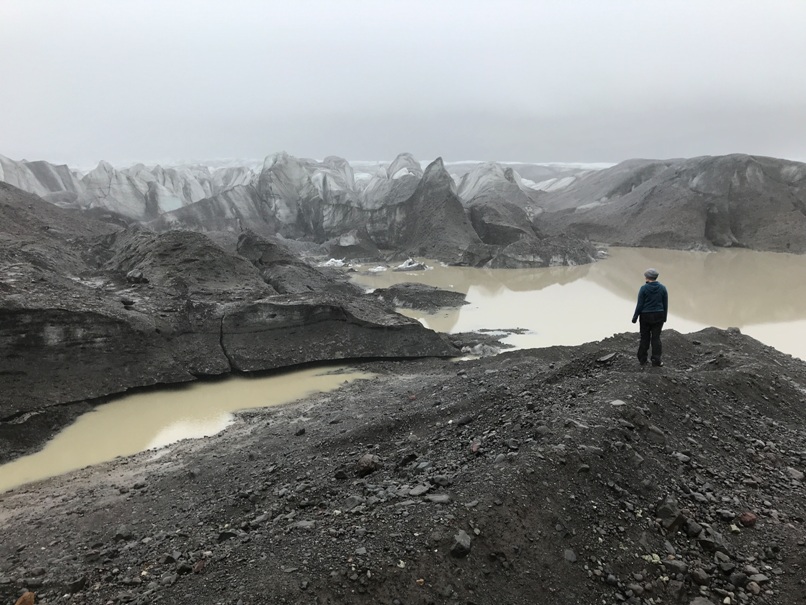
[0,0,806,166]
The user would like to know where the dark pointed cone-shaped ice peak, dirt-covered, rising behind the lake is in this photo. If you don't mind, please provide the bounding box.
[397,158,492,266]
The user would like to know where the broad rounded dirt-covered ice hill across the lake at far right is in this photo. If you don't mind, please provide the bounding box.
[536,155,806,253]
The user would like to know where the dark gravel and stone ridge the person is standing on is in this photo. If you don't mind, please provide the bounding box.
[0,329,806,605]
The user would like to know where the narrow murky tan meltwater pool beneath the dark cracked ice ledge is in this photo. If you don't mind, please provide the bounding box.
[0,368,372,492]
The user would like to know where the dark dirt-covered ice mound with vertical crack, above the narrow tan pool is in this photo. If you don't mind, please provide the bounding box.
[0,183,457,460]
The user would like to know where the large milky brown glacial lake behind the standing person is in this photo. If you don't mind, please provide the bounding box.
[354,248,806,359]
